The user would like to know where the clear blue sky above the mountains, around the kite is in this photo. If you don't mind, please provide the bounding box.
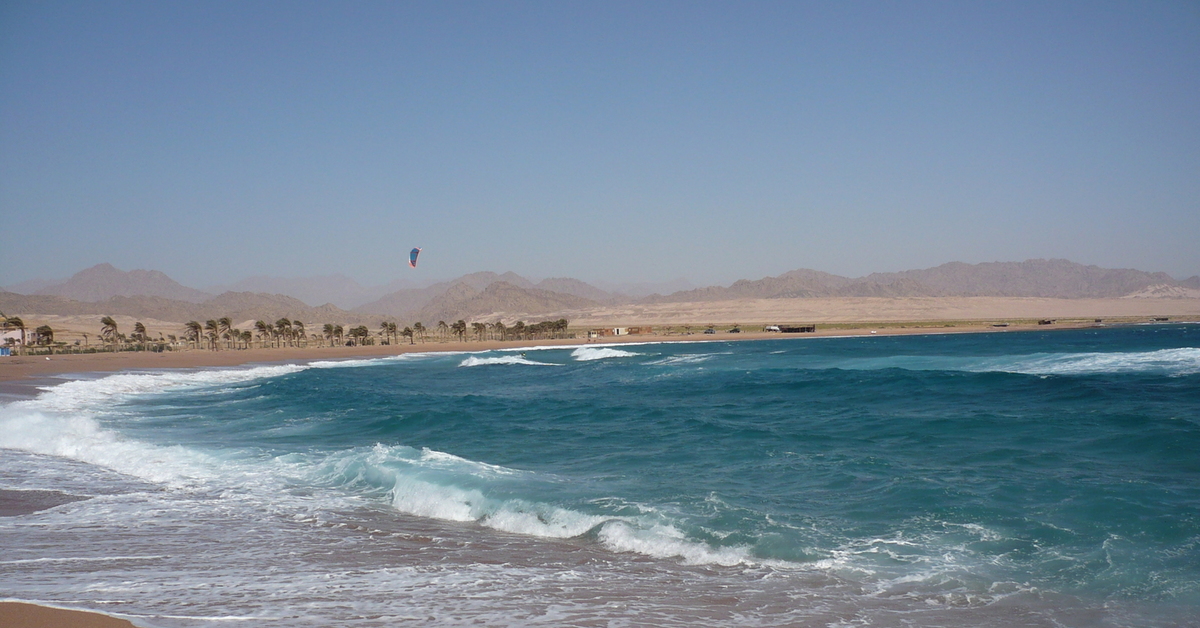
[0,1,1200,286]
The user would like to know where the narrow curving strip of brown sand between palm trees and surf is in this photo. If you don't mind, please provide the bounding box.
[0,321,1180,389]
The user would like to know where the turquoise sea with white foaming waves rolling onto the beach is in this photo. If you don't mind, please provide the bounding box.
[0,324,1200,627]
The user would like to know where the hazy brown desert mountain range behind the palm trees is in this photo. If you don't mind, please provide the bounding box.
[0,259,1200,324]
